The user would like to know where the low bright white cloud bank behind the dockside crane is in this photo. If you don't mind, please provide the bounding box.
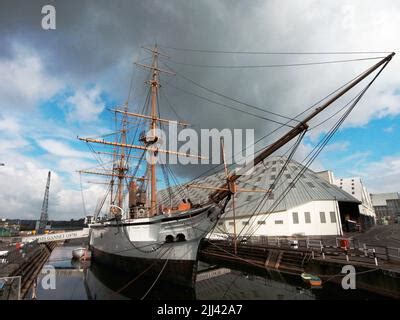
[0,156,104,220]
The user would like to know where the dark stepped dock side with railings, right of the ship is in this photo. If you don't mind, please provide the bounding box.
[200,240,400,299]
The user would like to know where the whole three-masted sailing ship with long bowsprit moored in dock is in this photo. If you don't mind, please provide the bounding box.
[79,46,394,286]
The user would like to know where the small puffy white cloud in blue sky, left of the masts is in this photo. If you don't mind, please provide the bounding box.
[65,86,105,122]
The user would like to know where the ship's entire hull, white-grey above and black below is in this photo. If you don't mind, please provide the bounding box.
[90,206,219,287]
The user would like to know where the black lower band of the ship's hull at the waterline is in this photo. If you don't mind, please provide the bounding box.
[91,247,197,288]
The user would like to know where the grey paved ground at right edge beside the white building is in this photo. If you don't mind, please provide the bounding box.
[348,223,400,248]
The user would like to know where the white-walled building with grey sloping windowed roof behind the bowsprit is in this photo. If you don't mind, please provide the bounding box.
[159,157,360,236]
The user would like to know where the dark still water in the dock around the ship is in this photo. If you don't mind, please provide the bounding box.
[26,244,394,300]
